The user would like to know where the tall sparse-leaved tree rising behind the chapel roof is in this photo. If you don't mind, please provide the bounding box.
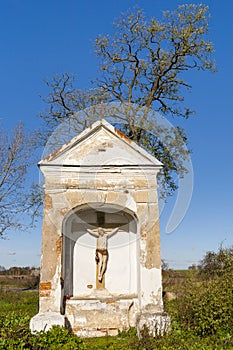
[38,4,215,194]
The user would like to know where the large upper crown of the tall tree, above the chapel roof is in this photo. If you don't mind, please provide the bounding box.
[96,4,214,117]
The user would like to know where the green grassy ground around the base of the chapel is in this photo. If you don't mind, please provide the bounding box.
[0,271,233,350]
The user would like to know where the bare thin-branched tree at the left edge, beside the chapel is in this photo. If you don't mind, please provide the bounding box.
[0,124,37,237]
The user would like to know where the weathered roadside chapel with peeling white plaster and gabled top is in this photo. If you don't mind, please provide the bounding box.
[30,119,169,337]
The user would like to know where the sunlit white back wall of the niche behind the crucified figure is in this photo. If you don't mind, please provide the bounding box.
[73,231,137,296]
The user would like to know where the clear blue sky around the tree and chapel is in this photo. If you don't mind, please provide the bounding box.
[0,0,233,268]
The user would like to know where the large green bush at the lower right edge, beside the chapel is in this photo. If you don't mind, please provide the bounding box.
[177,271,233,336]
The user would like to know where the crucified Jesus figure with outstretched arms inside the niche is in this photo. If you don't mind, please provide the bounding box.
[87,227,119,282]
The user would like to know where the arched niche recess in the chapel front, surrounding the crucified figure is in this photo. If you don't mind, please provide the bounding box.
[62,203,139,298]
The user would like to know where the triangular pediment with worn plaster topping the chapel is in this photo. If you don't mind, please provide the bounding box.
[39,119,162,167]
